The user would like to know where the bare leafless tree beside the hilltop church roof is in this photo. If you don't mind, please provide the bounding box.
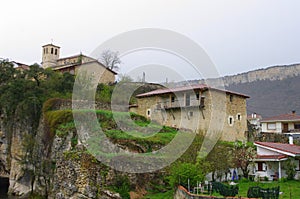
[99,50,121,70]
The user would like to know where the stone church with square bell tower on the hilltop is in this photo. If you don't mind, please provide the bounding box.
[42,44,117,84]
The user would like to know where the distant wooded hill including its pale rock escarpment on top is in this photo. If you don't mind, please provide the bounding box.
[224,64,300,117]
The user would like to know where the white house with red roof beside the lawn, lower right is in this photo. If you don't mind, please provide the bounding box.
[252,142,300,180]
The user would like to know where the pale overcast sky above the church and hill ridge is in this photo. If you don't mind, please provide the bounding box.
[0,0,300,79]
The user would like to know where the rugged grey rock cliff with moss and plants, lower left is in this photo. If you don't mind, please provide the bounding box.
[0,100,164,199]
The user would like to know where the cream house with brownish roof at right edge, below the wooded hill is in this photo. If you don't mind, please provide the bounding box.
[260,111,300,134]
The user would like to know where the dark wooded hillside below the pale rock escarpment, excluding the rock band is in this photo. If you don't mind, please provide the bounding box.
[227,75,300,117]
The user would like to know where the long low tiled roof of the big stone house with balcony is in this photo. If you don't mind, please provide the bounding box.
[136,84,249,98]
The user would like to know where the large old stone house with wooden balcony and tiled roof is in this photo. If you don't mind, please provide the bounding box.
[130,84,249,141]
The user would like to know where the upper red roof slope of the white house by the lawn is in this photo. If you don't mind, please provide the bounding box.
[255,142,300,156]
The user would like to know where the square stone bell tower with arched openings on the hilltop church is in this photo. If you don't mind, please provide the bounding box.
[42,44,60,68]
